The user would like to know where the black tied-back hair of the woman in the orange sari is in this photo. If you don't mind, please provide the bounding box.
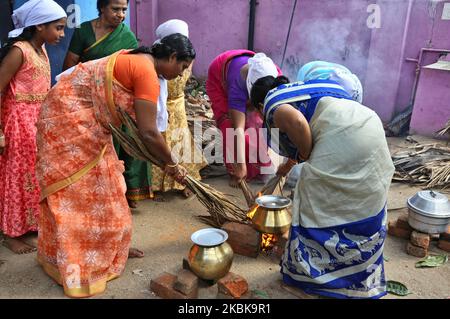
[130,33,196,61]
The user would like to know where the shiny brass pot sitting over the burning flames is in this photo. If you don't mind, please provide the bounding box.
[252,195,292,234]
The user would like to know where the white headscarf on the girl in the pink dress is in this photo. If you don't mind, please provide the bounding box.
[8,0,67,38]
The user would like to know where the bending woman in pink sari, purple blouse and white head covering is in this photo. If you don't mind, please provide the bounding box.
[206,50,281,187]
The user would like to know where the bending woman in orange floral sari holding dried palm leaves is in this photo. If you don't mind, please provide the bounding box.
[37,34,195,297]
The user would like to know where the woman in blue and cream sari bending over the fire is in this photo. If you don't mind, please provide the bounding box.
[251,61,394,298]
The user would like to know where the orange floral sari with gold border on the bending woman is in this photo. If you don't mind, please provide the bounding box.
[36,51,134,297]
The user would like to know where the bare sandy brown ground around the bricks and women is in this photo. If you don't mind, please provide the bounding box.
[0,138,450,299]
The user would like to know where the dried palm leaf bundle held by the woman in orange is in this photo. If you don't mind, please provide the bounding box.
[109,108,247,227]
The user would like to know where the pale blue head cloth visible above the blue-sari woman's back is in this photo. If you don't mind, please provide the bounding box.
[297,61,363,103]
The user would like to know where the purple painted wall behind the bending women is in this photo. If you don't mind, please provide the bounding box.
[131,0,450,132]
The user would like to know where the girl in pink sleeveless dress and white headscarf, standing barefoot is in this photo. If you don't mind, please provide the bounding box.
[0,0,67,254]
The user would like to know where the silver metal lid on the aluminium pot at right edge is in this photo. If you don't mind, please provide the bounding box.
[408,190,450,218]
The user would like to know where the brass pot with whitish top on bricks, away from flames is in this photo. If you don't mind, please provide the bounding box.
[188,228,234,280]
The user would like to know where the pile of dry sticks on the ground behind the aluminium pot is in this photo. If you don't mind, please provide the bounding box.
[392,143,450,190]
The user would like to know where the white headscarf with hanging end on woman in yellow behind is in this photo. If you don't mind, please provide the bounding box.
[155,19,189,132]
